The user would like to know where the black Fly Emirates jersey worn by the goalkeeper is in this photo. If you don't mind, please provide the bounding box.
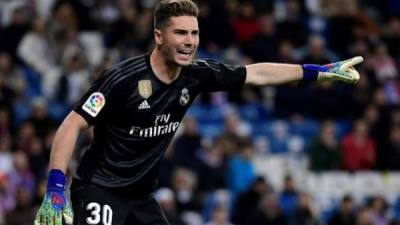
[74,54,246,195]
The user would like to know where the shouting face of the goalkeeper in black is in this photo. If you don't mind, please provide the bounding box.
[155,16,199,66]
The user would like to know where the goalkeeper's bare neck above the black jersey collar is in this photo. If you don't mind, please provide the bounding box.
[150,48,182,84]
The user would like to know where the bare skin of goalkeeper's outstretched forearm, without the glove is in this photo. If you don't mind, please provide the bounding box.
[245,63,303,86]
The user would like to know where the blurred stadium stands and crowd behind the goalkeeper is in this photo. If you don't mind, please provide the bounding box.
[0,0,400,225]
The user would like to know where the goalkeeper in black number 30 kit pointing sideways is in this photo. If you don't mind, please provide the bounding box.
[35,0,362,225]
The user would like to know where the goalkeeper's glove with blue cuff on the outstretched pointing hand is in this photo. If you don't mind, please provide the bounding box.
[303,56,364,84]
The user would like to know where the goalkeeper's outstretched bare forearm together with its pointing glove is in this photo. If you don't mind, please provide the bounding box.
[245,56,363,85]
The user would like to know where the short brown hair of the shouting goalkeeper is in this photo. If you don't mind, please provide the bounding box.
[154,0,199,29]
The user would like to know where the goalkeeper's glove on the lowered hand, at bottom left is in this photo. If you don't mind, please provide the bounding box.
[35,169,73,225]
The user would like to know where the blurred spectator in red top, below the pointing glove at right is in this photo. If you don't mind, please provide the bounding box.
[342,119,376,171]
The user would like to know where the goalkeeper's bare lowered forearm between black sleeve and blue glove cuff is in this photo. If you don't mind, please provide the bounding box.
[49,111,89,173]
